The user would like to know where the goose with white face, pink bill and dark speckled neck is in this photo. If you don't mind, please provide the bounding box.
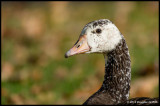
[65,19,159,105]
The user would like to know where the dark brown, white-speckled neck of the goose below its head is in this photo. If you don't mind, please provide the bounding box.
[100,38,131,103]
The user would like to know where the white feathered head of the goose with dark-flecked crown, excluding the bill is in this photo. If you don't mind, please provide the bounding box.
[81,19,123,53]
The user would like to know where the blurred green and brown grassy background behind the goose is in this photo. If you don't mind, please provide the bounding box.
[1,2,159,104]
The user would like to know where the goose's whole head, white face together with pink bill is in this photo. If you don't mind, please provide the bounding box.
[65,19,123,58]
